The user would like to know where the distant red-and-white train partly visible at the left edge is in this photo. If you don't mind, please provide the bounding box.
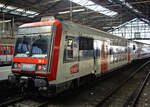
[0,44,14,65]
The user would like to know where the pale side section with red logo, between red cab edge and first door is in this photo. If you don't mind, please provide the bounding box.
[56,25,94,83]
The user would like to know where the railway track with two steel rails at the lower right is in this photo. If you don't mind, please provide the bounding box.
[96,61,150,107]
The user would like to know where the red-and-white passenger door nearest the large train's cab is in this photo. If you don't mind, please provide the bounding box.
[101,41,108,73]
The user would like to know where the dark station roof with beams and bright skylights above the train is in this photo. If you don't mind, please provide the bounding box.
[0,0,150,31]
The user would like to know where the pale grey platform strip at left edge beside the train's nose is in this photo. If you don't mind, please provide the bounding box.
[0,66,11,81]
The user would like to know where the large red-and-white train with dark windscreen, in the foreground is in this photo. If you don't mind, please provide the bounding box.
[8,17,149,95]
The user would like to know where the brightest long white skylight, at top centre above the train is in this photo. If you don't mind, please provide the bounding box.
[70,0,118,17]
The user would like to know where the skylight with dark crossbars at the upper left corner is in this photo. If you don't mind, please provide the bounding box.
[0,3,39,18]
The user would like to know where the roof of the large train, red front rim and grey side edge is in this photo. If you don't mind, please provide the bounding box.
[19,20,149,45]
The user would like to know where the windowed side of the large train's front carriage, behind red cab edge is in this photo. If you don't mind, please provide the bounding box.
[55,24,131,84]
